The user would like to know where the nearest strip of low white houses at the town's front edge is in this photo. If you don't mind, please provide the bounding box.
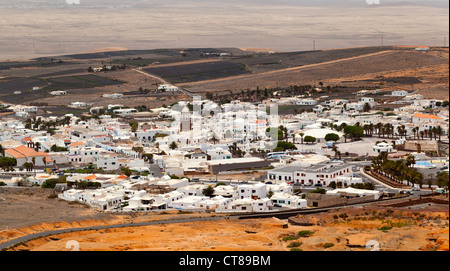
[55,175,307,213]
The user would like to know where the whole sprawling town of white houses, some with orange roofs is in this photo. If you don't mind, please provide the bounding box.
[0,85,449,215]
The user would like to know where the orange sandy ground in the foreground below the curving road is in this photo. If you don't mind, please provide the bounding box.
[5,209,449,251]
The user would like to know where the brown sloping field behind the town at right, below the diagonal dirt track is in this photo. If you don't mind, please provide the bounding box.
[182,49,448,97]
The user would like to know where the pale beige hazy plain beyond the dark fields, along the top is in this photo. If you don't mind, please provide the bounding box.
[0,0,449,59]
